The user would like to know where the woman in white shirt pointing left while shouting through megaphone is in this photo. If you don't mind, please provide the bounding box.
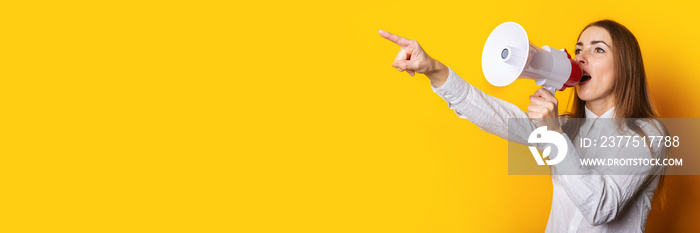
[379,20,667,232]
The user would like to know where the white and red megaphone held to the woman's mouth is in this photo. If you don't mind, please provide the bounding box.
[481,22,583,95]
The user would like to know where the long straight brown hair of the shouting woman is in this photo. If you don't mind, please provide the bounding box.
[562,19,668,208]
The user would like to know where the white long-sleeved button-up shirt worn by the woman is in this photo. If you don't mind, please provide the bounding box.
[431,68,662,232]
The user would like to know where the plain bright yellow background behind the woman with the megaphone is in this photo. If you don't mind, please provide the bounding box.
[0,1,700,232]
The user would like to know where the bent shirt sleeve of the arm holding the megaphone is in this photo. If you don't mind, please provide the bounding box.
[553,121,668,226]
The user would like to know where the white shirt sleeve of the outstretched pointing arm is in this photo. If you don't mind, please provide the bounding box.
[431,67,534,144]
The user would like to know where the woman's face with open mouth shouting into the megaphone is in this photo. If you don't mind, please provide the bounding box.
[574,26,615,102]
